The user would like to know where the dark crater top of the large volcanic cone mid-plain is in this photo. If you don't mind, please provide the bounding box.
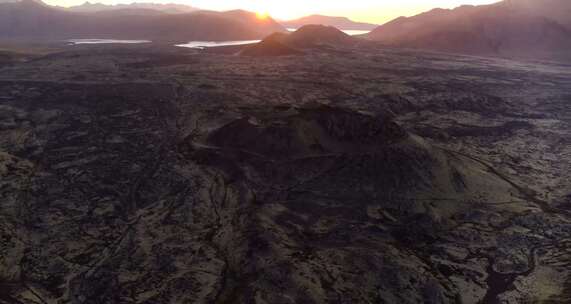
[208,104,409,159]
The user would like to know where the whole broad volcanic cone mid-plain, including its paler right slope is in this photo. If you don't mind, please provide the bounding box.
[194,106,511,209]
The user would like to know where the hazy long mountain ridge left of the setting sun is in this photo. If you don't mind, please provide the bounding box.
[0,0,286,42]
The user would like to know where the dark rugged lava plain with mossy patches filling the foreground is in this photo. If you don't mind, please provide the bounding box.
[0,41,571,304]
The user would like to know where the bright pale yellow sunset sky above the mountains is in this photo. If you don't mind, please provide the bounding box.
[44,0,499,24]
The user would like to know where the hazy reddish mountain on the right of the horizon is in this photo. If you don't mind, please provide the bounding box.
[366,0,571,59]
